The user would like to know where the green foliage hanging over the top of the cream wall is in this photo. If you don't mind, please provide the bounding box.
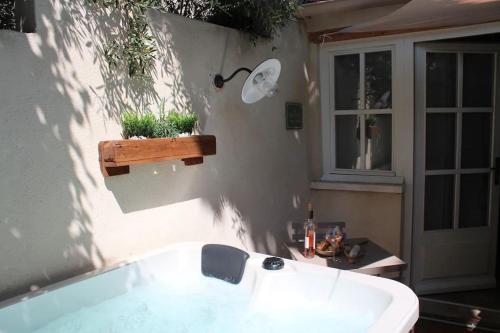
[88,0,299,78]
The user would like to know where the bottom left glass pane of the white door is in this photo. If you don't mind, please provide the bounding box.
[424,175,455,231]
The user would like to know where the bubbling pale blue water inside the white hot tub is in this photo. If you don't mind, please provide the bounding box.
[33,279,373,333]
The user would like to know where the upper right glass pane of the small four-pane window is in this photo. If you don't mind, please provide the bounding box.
[365,51,392,109]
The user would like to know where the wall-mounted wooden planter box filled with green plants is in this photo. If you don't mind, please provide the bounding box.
[99,104,216,177]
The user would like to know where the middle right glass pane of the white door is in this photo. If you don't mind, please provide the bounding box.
[461,112,491,168]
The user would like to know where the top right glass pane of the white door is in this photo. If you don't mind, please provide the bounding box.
[463,53,494,107]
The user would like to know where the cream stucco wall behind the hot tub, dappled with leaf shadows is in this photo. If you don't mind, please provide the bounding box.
[0,0,309,299]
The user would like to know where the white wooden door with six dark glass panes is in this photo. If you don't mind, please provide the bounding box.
[412,44,500,294]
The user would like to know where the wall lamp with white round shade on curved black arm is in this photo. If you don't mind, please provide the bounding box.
[214,59,281,104]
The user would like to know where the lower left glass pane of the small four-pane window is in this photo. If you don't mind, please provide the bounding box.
[335,116,361,169]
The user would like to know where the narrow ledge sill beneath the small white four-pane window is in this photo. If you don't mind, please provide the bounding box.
[310,181,403,194]
